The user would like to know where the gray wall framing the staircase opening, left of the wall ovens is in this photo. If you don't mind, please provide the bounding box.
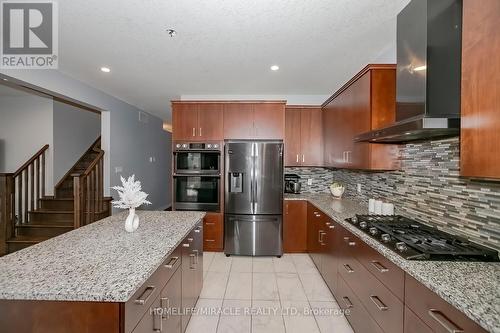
[0,69,172,209]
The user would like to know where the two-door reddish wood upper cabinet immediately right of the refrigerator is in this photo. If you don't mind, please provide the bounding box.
[285,106,323,166]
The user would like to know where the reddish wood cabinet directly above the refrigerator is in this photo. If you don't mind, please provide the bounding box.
[224,101,285,140]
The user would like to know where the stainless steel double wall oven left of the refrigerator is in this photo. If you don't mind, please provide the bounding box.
[174,142,221,212]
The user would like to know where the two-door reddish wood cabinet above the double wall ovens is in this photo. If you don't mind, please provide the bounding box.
[172,101,223,141]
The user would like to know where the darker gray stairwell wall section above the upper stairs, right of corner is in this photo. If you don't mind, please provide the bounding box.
[54,101,101,183]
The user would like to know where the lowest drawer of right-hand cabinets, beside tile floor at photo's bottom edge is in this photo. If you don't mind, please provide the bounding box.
[336,276,383,333]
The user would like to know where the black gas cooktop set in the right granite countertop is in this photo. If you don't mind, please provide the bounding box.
[346,215,500,261]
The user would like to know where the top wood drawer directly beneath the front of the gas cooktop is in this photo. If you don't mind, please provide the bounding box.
[355,237,405,301]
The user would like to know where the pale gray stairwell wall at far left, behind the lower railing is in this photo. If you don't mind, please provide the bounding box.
[0,94,54,195]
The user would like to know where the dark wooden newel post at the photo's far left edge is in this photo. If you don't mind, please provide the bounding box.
[0,173,15,256]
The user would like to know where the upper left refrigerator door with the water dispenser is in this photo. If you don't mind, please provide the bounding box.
[224,142,255,214]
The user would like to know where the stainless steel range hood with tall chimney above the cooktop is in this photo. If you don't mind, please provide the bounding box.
[354,0,462,143]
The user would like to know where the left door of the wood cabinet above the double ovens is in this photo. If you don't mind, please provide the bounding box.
[172,103,198,141]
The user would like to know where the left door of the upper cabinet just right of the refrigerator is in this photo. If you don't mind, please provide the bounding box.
[285,107,302,166]
